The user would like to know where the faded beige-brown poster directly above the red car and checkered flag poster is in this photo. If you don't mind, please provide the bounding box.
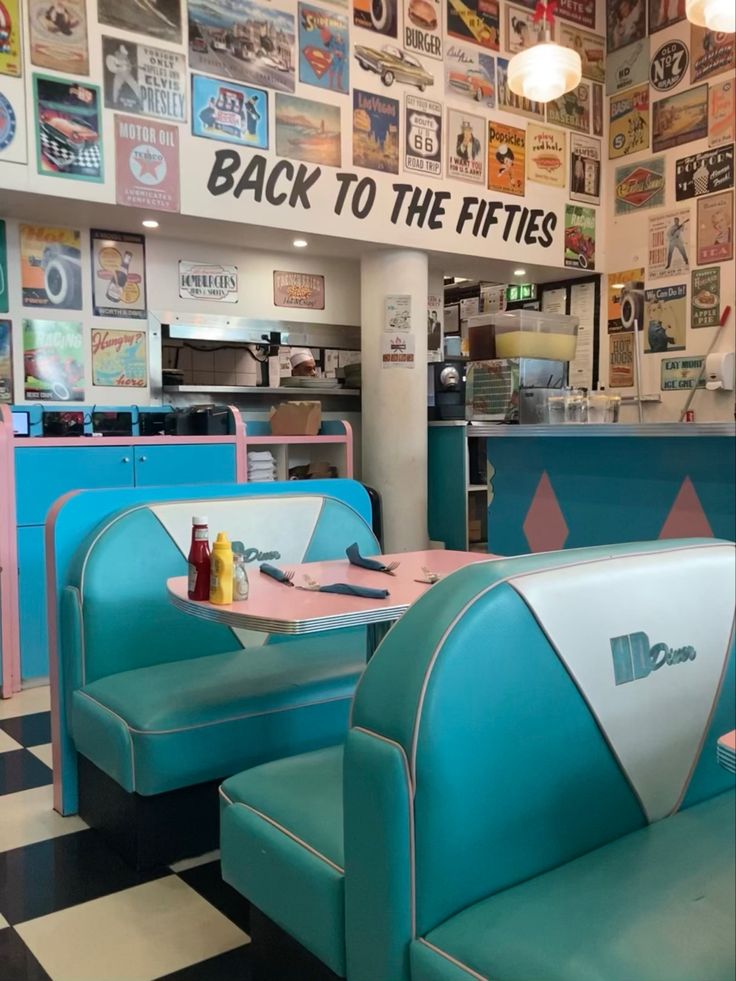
[27,0,89,75]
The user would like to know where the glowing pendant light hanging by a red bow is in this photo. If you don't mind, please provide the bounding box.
[507,0,580,102]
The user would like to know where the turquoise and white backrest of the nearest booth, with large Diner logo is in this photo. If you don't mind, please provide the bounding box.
[345,540,736,948]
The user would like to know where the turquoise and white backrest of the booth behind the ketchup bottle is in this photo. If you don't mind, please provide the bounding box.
[62,491,379,688]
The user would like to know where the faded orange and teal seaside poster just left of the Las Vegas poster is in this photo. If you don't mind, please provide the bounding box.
[274,93,342,167]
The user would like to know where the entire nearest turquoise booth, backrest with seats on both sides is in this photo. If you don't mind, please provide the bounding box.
[220,540,736,981]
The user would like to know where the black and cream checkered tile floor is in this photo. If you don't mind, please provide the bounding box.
[0,688,251,981]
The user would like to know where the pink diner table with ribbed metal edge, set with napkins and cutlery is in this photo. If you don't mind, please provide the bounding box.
[166,549,494,658]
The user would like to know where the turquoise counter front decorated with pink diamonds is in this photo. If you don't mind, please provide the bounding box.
[429,423,736,555]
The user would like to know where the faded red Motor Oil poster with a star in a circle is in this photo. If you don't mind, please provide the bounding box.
[115,115,179,211]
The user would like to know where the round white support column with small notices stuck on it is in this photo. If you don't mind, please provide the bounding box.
[361,250,428,552]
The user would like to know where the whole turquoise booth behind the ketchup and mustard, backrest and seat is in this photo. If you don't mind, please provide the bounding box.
[60,481,380,813]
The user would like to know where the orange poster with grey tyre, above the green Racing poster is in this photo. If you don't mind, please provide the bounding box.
[20,225,82,310]
